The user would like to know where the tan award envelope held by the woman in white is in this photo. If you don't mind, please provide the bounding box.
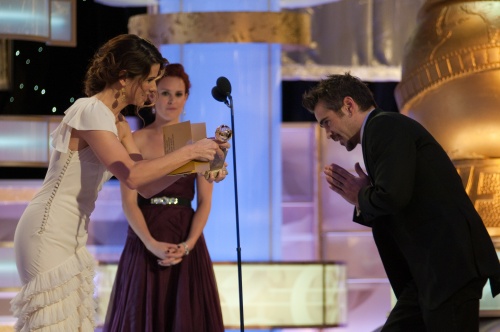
[163,121,210,175]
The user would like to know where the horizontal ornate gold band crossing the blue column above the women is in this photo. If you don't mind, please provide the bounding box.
[128,12,311,49]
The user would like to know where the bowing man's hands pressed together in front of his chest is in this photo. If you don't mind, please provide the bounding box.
[323,163,371,208]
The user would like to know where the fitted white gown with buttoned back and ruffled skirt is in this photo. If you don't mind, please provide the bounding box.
[11,97,118,332]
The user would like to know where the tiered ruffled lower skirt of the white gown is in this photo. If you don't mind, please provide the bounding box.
[10,247,97,332]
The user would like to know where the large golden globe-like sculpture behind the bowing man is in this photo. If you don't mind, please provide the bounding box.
[395,0,500,235]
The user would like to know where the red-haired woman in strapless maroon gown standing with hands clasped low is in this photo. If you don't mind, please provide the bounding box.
[104,64,224,332]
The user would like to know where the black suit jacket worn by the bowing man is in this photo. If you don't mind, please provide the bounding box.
[354,109,500,309]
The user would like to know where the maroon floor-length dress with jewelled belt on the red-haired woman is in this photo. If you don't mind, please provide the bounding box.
[103,174,224,332]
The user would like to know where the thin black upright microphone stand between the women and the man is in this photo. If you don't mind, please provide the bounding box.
[224,93,245,332]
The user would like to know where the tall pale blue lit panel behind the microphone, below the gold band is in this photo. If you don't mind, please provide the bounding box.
[162,43,281,261]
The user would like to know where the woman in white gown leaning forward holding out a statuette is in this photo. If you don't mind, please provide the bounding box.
[11,34,224,332]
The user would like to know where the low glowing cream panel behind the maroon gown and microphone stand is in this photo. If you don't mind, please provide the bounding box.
[96,262,347,329]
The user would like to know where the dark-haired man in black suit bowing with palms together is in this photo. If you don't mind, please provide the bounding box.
[303,73,500,332]
